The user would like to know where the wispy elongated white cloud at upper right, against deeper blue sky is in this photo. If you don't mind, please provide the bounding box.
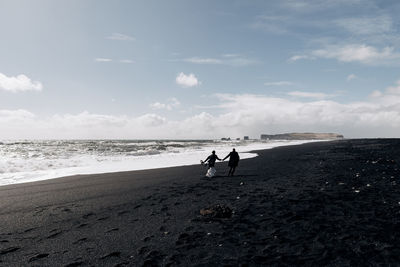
[312,44,400,64]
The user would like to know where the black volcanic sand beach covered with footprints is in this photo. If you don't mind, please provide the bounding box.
[0,139,400,266]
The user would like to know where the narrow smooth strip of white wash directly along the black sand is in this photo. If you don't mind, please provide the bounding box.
[0,140,318,187]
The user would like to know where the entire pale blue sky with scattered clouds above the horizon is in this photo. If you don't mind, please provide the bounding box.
[0,0,400,139]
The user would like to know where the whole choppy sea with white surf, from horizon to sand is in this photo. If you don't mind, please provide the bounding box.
[0,140,310,186]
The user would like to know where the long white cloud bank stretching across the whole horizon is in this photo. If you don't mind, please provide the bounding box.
[0,81,400,139]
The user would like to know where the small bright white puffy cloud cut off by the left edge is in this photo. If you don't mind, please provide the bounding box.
[0,73,43,92]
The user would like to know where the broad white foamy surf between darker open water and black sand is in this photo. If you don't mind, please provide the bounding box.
[0,141,316,185]
